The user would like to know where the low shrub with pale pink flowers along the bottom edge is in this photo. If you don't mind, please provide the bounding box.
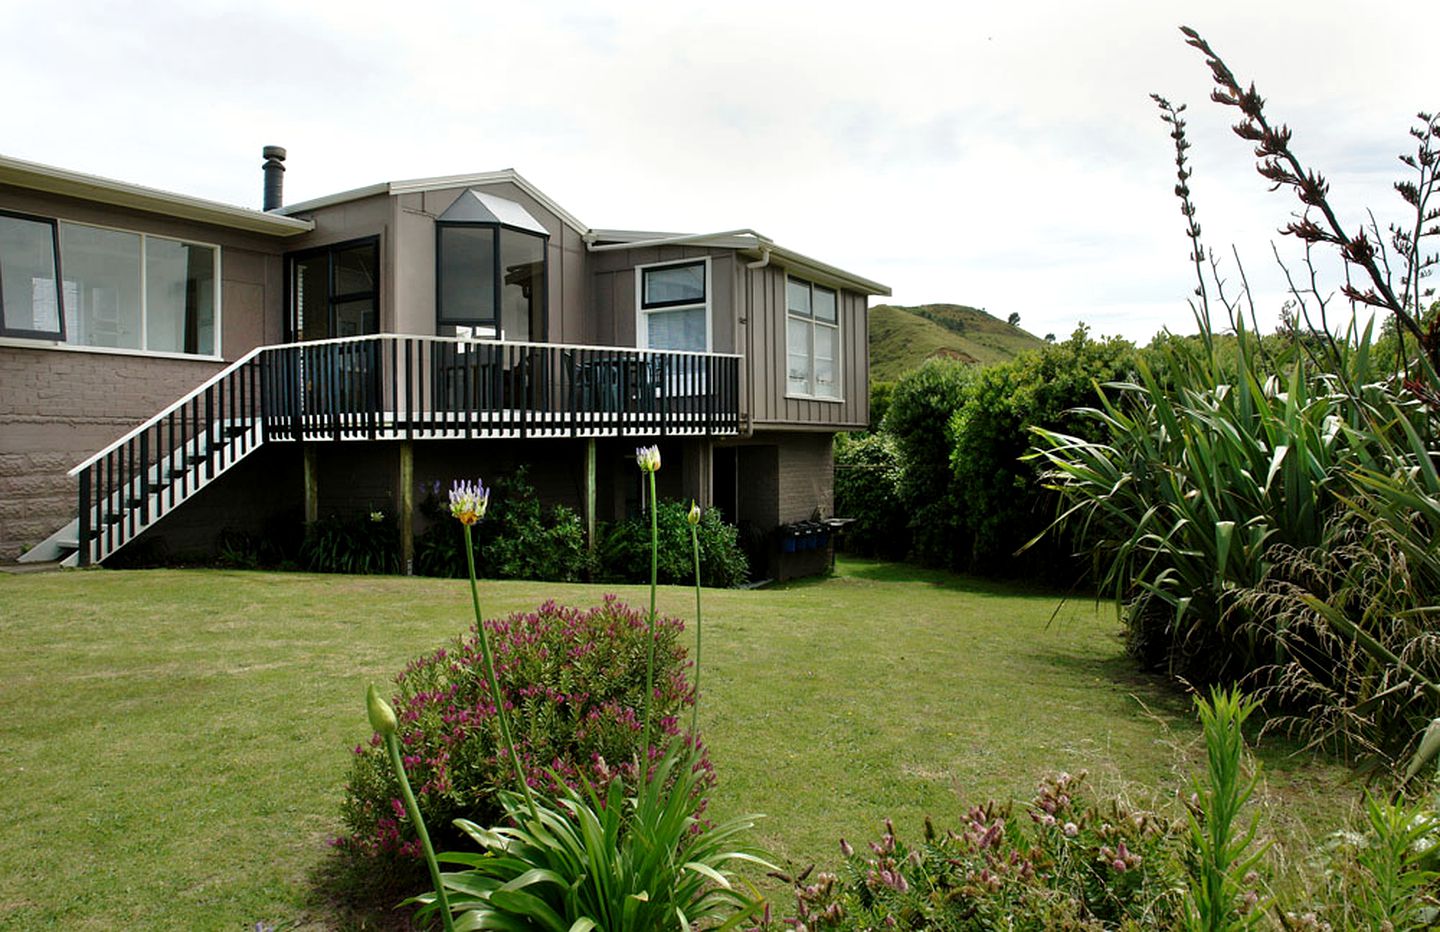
[757,774,1184,931]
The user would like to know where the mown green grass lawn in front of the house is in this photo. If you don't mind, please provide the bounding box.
[0,560,1355,929]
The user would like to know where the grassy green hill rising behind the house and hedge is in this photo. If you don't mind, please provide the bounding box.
[870,304,1044,382]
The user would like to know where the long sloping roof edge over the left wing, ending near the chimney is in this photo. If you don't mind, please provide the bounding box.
[0,156,315,236]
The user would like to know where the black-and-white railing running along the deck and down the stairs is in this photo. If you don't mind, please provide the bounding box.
[71,334,740,565]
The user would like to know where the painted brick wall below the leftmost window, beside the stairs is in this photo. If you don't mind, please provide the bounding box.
[0,346,220,562]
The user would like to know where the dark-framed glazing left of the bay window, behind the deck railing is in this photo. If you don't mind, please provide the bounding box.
[288,236,380,340]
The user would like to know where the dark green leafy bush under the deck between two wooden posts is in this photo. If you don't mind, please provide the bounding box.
[415,467,595,582]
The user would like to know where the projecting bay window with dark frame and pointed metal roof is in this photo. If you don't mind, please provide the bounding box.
[435,190,550,341]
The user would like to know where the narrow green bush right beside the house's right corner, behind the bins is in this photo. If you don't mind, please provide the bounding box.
[835,432,910,560]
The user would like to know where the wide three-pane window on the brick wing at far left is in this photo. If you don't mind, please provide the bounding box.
[0,215,220,356]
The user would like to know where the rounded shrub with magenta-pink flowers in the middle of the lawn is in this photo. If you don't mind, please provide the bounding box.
[337,596,702,859]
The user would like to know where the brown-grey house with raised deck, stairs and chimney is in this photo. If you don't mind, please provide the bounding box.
[0,147,890,576]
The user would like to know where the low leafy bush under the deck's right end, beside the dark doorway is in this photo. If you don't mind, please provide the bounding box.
[600,501,750,588]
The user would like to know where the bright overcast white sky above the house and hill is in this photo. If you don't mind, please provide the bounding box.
[0,0,1440,341]
